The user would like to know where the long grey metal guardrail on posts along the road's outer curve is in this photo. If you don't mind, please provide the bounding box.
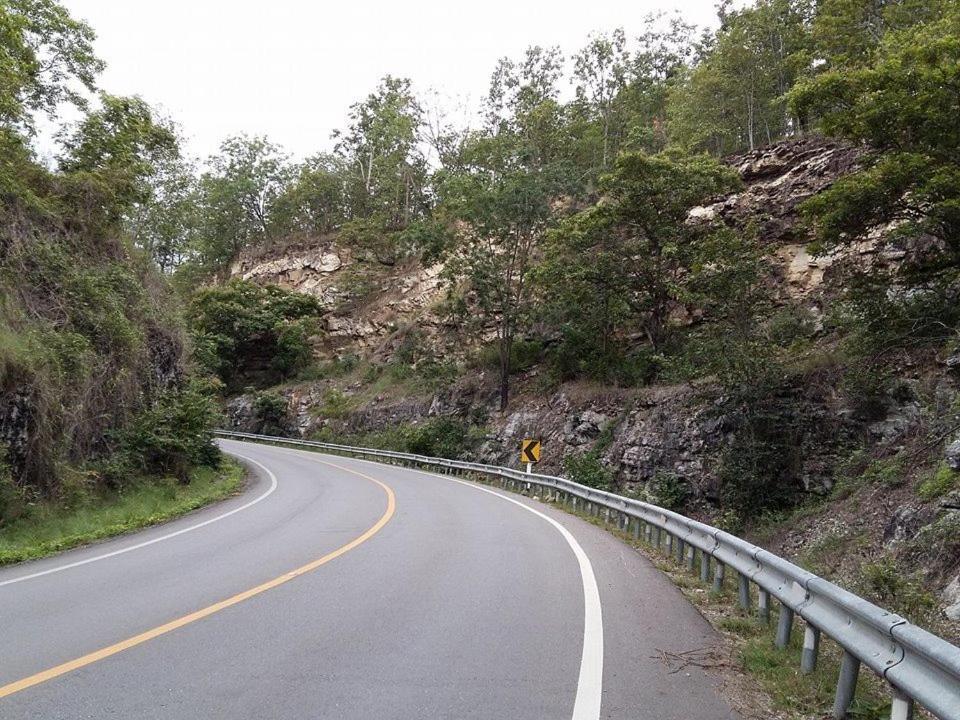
[217,431,960,720]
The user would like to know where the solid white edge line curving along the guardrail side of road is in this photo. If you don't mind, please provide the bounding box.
[280,448,603,720]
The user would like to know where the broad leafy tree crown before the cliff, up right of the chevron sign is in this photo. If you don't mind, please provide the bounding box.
[538,153,756,371]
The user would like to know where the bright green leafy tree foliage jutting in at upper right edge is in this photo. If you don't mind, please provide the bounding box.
[790,2,960,277]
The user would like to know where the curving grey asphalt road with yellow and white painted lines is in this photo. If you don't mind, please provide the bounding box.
[0,441,738,720]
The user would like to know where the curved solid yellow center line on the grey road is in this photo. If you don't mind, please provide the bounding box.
[0,460,397,698]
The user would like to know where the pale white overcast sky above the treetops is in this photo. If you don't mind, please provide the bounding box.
[62,0,715,162]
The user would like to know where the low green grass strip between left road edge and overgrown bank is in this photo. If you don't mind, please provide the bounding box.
[0,458,244,565]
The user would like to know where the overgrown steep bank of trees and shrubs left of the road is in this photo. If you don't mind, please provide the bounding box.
[0,0,225,536]
